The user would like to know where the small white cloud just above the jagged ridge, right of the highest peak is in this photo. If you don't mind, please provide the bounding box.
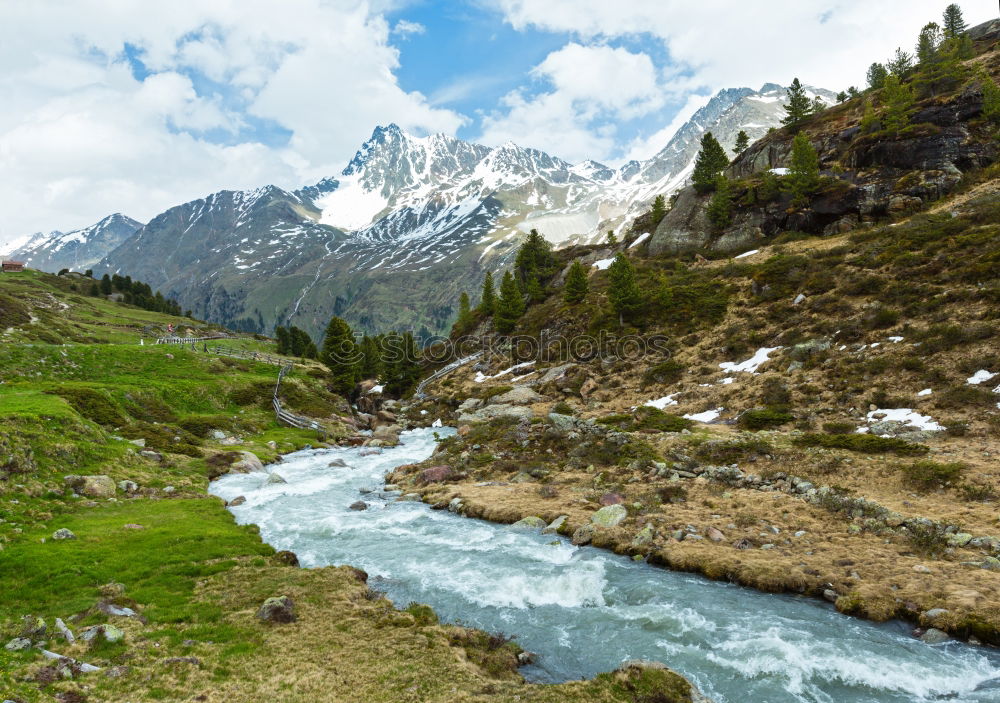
[480,42,665,161]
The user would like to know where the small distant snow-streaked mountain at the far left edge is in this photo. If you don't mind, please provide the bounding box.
[0,213,142,272]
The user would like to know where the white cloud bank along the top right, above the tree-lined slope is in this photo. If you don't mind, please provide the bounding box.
[493,0,996,95]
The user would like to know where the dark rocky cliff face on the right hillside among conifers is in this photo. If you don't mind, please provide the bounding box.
[648,46,1000,255]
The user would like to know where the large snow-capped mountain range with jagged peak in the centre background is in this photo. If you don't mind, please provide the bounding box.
[98,84,833,335]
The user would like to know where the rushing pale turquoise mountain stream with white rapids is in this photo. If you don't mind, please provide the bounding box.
[211,428,1000,703]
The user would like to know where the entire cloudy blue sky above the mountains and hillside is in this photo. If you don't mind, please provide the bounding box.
[0,0,997,243]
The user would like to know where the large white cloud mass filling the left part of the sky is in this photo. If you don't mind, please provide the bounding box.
[0,0,464,242]
